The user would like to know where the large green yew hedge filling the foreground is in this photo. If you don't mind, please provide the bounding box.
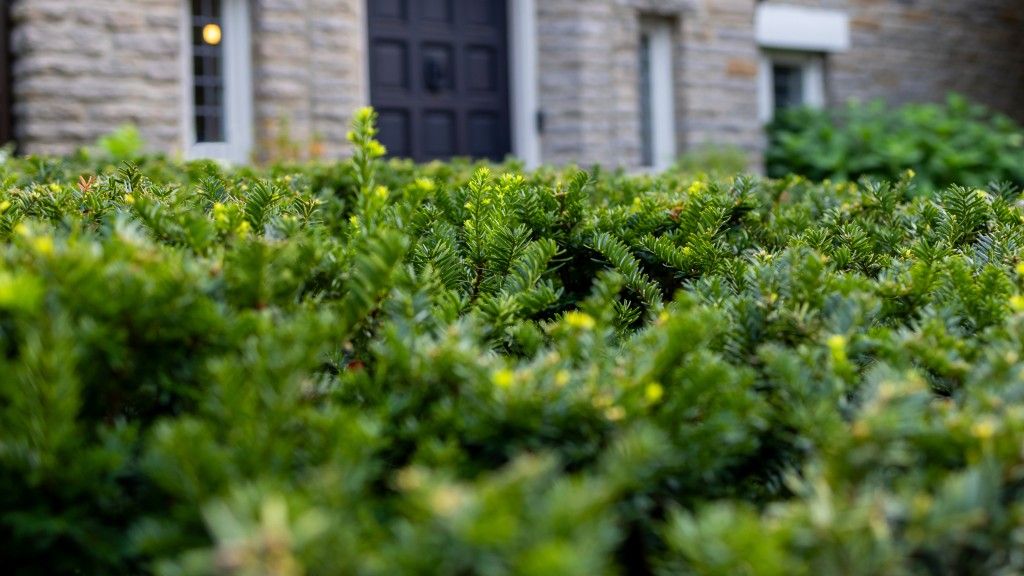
[0,106,1024,576]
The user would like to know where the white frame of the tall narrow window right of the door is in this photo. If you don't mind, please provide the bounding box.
[638,18,676,170]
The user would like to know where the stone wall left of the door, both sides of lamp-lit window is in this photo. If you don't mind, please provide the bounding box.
[11,0,367,159]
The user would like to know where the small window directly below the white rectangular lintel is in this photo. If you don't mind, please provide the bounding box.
[759,52,825,122]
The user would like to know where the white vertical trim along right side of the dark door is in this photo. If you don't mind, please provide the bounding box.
[508,0,541,168]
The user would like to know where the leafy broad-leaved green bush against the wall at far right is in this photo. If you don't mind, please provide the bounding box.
[768,95,1024,191]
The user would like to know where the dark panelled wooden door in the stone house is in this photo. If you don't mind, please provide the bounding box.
[367,0,511,162]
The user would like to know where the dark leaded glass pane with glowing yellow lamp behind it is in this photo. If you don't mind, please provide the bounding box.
[191,0,225,142]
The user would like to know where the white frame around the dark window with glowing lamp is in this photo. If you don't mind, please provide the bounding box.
[181,0,254,164]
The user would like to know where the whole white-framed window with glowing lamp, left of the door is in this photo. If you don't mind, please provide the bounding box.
[185,0,253,163]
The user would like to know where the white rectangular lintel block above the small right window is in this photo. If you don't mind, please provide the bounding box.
[755,4,850,52]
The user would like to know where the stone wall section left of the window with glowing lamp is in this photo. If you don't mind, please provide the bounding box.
[11,0,182,154]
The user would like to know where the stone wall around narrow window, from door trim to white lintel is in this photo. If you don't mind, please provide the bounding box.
[538,0,764,167]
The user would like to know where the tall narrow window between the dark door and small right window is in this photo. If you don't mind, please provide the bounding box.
[638,18,676,169]
